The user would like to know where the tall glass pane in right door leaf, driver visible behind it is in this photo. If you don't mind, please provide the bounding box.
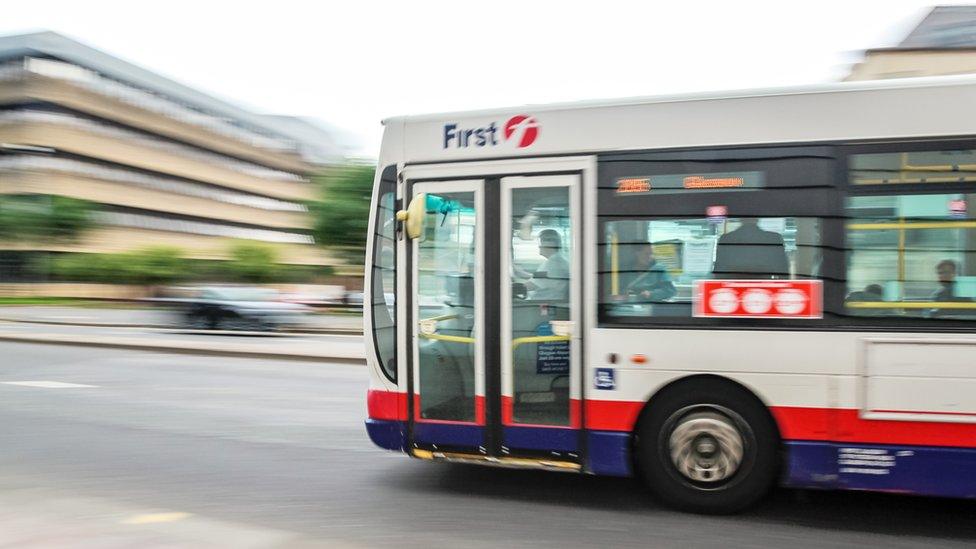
[505,187,575,426]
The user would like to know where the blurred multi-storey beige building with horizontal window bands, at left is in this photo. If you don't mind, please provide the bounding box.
[0,32,342,278]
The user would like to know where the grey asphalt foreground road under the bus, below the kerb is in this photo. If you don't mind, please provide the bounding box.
[0,343,976,548]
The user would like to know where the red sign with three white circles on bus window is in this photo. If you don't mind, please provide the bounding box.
[694,280,823,318]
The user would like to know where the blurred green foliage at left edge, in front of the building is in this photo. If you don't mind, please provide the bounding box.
[0,195,96,242]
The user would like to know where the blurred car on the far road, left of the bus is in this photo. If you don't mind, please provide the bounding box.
[181,286,311,331]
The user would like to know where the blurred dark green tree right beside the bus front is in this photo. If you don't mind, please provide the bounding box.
[309,164,375,264]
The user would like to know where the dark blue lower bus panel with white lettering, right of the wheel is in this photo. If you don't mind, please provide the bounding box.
[784,441,976,498]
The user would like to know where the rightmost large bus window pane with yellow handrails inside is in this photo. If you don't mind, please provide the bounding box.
[846,193,976,320]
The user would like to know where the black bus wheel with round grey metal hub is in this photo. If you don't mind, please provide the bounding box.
[635,380,780,514]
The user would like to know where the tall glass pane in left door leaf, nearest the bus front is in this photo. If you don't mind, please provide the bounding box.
[415,192,481,422]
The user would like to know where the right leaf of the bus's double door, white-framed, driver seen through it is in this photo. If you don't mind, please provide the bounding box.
[499,174,582,461]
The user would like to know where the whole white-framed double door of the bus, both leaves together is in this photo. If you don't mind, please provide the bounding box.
[408,174,581,462]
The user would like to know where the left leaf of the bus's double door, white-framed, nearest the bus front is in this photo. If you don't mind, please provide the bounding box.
[410,180,487,451]
